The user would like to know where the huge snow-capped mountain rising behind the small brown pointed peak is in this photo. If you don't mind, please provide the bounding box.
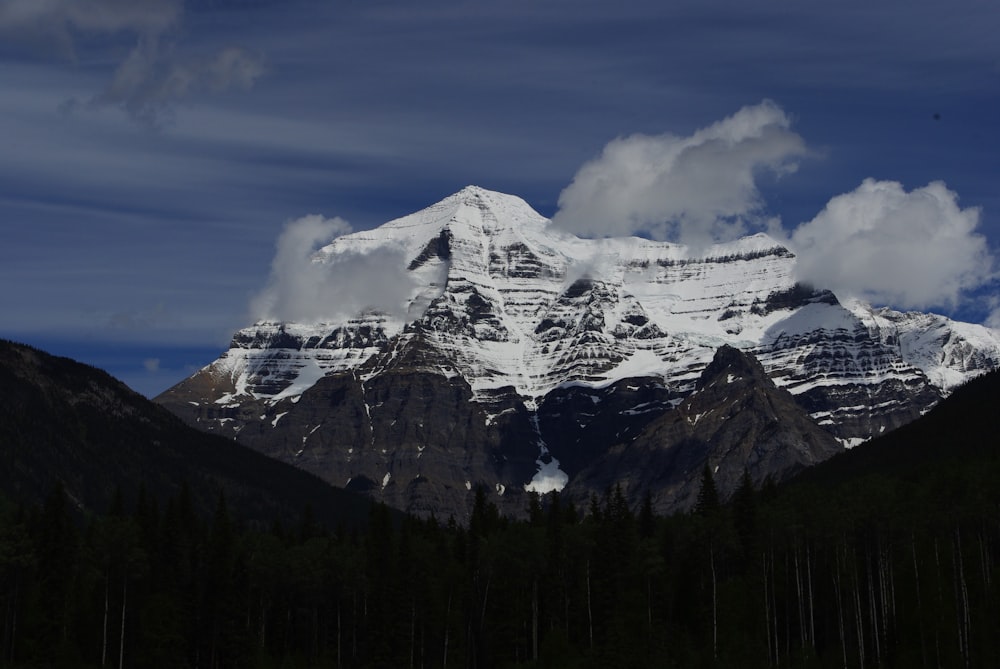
[158,186,1000,512]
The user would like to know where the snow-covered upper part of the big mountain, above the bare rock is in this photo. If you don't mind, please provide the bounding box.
[164,186,1000,443]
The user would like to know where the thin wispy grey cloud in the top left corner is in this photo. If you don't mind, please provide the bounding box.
[0,0,265,127]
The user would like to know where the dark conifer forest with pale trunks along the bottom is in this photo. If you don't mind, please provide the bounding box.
[0,463,1000,669]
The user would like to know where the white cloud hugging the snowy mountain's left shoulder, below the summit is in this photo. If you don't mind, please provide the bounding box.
[251,215,414,323]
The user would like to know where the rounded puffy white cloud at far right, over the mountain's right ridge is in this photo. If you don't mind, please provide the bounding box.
[788,179,994,309]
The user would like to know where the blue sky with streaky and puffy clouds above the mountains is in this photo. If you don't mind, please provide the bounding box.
[0,0,1000,395]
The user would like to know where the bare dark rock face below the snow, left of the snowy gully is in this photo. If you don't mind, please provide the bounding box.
[162,336,538,523]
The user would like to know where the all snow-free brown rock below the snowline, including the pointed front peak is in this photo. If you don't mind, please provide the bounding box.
[157,336,843,522]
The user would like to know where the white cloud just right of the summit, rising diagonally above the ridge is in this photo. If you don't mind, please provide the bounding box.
[553,100,807,246]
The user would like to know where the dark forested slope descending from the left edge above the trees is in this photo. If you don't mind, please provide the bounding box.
[0,341,378,526]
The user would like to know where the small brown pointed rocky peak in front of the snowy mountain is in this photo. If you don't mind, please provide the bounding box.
[555,346,844,514]
